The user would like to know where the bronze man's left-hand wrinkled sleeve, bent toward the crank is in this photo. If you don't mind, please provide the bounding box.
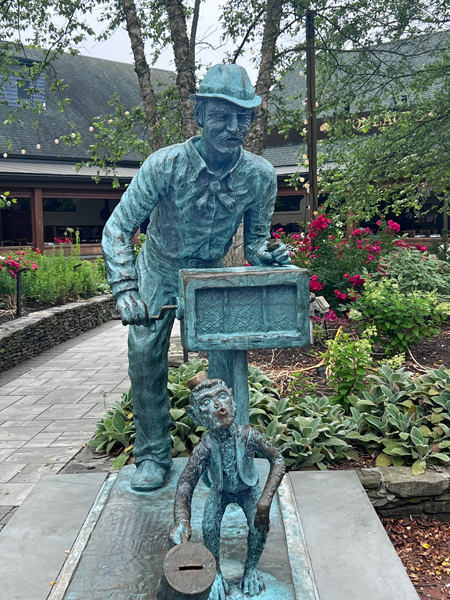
[102,149,166,296]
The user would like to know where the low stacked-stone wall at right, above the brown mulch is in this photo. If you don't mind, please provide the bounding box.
[357,467,450,521]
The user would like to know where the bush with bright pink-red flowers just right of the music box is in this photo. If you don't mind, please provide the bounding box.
[284,215,410,310]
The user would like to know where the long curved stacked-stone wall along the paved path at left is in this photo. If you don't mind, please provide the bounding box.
[0,294,116,372]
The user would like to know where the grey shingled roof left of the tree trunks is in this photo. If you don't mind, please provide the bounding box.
[0,51,173,163]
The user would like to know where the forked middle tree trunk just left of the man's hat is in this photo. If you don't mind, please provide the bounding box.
[164,0,200,140]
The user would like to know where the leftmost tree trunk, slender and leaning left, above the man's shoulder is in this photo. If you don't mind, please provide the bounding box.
[122,0,163,152]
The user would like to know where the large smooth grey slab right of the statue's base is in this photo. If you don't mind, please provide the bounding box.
[290,471,419,600]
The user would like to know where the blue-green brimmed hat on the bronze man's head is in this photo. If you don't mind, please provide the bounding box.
[190,64,261,108]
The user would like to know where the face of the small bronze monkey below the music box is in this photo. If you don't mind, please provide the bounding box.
[191,384,236,431]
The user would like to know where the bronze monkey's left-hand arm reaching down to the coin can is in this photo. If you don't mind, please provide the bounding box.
[173,442,211,525]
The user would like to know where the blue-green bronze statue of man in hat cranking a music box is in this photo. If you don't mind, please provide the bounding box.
[103,64,290,491]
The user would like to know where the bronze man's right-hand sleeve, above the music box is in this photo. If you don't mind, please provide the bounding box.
[244,158,277,266]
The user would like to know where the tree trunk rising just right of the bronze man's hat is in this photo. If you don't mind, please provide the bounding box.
[246,0,283,155]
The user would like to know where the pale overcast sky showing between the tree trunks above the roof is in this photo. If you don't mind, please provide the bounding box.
[79,0,259,83]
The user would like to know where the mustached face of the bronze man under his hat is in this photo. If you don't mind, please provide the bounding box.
[202,99,253,154]
